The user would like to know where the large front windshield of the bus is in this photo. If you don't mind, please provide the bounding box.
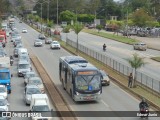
[75,75,101,91]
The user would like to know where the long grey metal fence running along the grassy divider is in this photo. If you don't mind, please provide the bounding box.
[66,39,160,94]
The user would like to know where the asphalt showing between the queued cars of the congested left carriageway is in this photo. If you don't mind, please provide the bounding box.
[5,23,59,120]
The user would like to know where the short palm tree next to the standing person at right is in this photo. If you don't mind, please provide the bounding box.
[126,53,146,87]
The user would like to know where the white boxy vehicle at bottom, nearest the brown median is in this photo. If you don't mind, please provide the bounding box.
[30,94,53,120]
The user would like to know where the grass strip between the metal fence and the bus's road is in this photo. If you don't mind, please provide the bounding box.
[60,41,160,107]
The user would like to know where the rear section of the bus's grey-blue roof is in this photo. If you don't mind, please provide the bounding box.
[61,56,88,64]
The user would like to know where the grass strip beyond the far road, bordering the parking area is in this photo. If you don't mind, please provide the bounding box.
[83,29,139,45]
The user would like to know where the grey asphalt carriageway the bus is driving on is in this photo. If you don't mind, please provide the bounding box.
[13,22,160,120]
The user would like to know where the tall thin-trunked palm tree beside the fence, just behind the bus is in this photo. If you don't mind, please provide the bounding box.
[72,22,84,54]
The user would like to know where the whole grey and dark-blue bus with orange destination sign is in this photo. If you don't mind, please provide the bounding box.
[59,56,102,101]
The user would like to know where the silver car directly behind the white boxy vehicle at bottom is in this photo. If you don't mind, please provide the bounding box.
[24,85,41,105]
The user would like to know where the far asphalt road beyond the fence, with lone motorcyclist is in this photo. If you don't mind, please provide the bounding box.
[61,32,160,80]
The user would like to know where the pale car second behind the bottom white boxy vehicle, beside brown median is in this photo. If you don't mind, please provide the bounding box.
[27,77,44,93]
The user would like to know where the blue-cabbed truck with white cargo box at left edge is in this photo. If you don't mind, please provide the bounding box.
[0,57,12,93]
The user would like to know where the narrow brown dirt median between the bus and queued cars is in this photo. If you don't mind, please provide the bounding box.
[31,55,76,120]
